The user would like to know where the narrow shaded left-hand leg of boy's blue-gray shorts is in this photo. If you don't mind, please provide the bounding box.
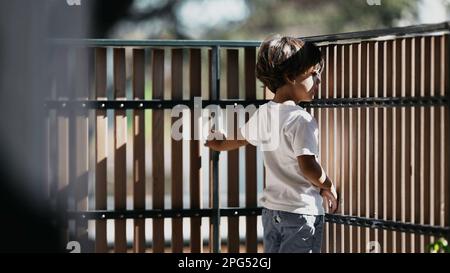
[262,208,281,253]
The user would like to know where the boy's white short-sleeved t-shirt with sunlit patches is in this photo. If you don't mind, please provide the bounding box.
[240,101,324,215]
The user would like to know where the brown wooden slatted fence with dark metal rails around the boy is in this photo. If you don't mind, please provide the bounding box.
[46,24,450,252]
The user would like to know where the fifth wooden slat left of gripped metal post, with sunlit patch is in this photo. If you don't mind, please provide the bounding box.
[114,48,127,253]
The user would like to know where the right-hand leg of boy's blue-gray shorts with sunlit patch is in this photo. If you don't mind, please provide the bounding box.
[280,212,324,253]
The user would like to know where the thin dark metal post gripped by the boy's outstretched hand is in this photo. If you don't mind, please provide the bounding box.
[210,46,220,253]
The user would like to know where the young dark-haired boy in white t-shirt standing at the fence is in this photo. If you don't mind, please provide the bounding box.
[205,36,338,253]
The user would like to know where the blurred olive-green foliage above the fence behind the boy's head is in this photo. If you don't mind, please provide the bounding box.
[216,0,418,39]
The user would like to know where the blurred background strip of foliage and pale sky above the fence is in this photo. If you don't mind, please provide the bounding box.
[92,0,419,40]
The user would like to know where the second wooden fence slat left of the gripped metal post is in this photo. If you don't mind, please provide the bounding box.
[171,48,183,253]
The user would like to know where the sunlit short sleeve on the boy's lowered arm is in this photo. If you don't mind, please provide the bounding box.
[288,116,319,157]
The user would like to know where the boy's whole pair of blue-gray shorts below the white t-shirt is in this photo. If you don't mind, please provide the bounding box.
[262,208,324,253]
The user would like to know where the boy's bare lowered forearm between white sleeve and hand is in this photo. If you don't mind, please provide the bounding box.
[297,155,332,190]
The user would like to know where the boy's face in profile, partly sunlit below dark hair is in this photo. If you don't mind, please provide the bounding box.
[293,64,322,102]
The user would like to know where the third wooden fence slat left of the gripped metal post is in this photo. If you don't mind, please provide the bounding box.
[152,49,165,253]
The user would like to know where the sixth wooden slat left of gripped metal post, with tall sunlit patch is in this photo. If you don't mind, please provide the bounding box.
[95,48,108,252]
